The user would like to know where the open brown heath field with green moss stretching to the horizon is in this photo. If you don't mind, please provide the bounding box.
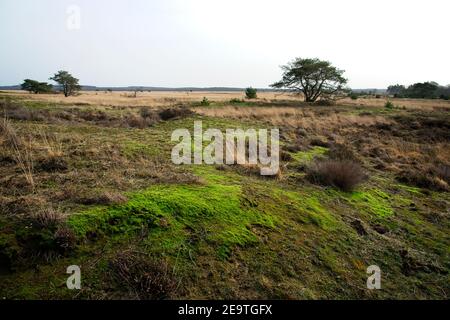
[0,91,450,299]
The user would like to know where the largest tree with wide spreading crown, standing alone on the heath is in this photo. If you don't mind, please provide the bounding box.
[271,58,348,102]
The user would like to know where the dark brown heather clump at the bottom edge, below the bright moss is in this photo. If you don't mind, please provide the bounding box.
[110,251,177,300]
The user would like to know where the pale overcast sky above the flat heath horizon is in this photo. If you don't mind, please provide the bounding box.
[0,0,450,88]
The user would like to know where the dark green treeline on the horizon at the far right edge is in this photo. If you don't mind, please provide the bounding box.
[387,82,450,100]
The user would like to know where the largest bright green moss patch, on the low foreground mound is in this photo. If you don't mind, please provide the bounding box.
[69,179,274,257]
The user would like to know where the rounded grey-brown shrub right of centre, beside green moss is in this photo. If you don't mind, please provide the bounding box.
[307,160,365,192]
